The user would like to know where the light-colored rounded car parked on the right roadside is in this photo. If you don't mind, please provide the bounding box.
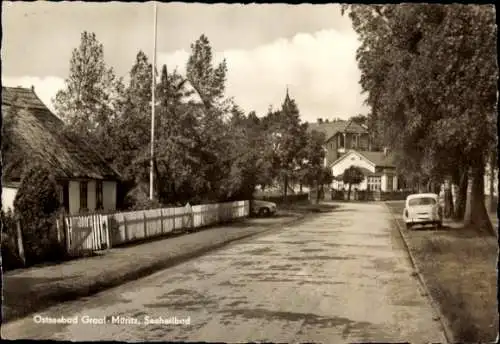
[403,193,443,229]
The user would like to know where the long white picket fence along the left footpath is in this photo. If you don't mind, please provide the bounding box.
[64,201,250,256]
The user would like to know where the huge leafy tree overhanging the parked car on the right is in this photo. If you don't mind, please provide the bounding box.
[344,4,498,229]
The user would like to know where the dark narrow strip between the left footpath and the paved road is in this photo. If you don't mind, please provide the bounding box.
[1,212,308,324]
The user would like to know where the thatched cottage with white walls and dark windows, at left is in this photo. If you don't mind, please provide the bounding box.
[2,87,120,214]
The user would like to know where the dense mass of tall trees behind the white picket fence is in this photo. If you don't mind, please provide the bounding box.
[50,32,328,206]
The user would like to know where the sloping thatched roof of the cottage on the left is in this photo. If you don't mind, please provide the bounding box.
[2,87,120,181]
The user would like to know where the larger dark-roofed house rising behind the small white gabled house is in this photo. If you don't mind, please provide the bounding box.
[308,120,371,166]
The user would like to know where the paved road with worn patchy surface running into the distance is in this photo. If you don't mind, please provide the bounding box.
[2,203,446,343]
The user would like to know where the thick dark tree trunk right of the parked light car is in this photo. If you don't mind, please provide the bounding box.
[464,164,494,233]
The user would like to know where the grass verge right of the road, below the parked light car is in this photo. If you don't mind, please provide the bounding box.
[386,202,499,343]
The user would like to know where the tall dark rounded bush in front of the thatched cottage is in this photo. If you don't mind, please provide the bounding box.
[14,165,63,265]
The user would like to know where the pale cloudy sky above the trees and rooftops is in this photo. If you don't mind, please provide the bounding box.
[1,1,369,122]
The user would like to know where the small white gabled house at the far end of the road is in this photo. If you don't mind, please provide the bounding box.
[330,150,398,192]
